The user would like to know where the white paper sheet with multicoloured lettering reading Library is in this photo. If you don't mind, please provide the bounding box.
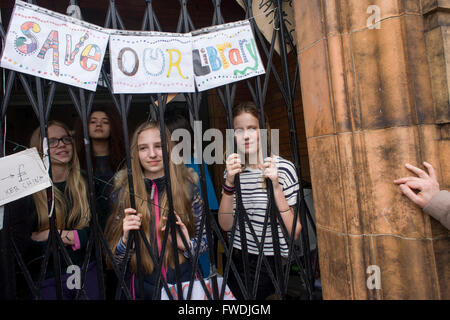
[192,20,265,91]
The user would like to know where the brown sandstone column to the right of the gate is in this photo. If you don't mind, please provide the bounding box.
[293,0,450,299]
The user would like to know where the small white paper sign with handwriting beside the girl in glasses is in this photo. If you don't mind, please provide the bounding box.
[0,148,52,206]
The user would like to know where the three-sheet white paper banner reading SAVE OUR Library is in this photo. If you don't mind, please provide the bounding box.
[0,0,265,94]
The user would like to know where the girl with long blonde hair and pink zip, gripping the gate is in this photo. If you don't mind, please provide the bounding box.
[105,121,207,299]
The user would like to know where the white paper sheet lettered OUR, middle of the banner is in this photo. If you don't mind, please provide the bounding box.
[109,31,195,93]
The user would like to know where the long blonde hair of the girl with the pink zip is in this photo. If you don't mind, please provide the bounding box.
[105,121,198,274]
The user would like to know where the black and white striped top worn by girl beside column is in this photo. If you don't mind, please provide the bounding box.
[224,156,299,257]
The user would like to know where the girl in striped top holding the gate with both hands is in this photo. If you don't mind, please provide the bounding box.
[219,102,301,300]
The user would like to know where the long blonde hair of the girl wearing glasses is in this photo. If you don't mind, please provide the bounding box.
[30,121,91,231]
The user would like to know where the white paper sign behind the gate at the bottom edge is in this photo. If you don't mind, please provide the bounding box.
[161,277,236,300]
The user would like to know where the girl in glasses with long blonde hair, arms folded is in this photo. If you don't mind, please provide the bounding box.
[30,121,99,300]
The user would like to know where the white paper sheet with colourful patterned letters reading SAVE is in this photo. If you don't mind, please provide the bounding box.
[0,1,109,91]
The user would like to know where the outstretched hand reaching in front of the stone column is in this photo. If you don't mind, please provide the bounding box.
[394,162,440,209]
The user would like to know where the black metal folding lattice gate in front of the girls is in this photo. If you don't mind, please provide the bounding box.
[0,0,318,300]
